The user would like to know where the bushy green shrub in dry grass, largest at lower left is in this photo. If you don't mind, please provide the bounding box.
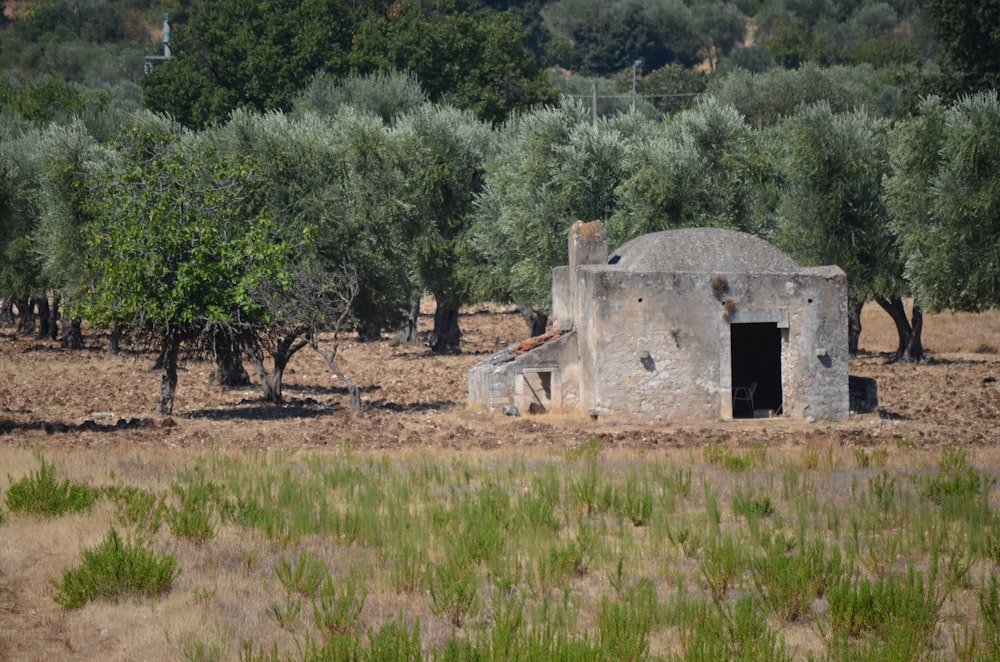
[52,528,180,609]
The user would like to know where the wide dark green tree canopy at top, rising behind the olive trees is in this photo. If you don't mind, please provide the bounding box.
[142,0,555,127]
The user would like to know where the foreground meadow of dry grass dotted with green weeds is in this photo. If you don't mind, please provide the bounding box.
[0,438,1000,661]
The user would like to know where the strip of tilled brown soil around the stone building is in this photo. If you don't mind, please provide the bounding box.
[0,304,1000,452]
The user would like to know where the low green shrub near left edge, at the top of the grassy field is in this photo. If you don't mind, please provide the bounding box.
[4,453,100,516]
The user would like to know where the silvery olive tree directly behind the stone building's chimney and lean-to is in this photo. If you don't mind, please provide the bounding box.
[470,104,651,335]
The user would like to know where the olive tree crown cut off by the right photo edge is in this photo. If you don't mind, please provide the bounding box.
[885,92,1000,311]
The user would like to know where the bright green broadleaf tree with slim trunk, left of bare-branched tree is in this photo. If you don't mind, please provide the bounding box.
[83,118,288,414]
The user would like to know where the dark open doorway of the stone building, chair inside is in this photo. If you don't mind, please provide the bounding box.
[729,322,781,418]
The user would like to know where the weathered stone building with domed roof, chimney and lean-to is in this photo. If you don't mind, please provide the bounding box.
[469,221,849,422]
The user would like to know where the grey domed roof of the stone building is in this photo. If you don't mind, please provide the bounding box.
[608,228,800,273]
